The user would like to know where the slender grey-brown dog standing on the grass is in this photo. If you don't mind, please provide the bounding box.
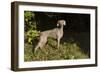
[34,20,66,52]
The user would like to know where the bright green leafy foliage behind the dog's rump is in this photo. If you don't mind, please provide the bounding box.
[24,11,39,44]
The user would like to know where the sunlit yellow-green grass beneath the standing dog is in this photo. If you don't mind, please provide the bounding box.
[24,38,89,61]
